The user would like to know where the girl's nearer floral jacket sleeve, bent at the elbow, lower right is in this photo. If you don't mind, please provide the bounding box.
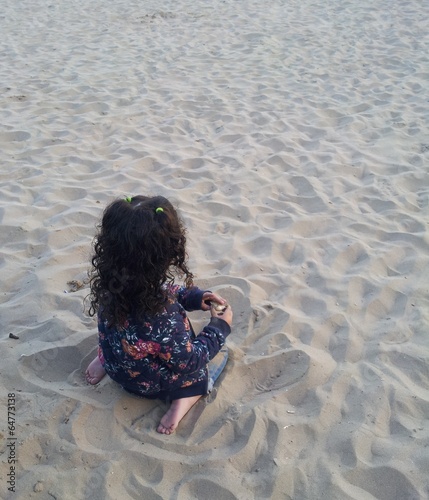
[160,314,231,374]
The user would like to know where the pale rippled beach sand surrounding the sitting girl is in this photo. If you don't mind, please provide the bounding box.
[0,0,429,500]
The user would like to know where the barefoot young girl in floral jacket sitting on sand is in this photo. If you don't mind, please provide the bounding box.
[86,196,232,434]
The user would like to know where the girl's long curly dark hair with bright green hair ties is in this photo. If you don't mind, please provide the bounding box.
[89,196,193,325]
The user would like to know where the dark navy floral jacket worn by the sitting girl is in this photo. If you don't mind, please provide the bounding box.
[98,285,231,399]
